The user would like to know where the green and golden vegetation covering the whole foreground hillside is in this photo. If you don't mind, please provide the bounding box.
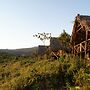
[0,55,90,90]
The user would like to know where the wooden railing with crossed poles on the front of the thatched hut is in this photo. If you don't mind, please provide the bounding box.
[74,39,90,54]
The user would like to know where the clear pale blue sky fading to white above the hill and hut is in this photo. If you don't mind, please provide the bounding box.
[0,0,90,49]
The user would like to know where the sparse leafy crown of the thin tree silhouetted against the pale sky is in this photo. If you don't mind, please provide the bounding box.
[33,32,51,45]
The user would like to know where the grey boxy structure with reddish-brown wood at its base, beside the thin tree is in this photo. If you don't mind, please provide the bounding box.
[50,37,67,59]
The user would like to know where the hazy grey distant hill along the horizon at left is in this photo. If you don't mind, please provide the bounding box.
[0,47,38,56]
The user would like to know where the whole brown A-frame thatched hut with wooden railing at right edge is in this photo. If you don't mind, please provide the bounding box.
[71,14,90,58]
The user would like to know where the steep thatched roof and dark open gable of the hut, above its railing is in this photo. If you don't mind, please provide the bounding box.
[71,14,90,44]
